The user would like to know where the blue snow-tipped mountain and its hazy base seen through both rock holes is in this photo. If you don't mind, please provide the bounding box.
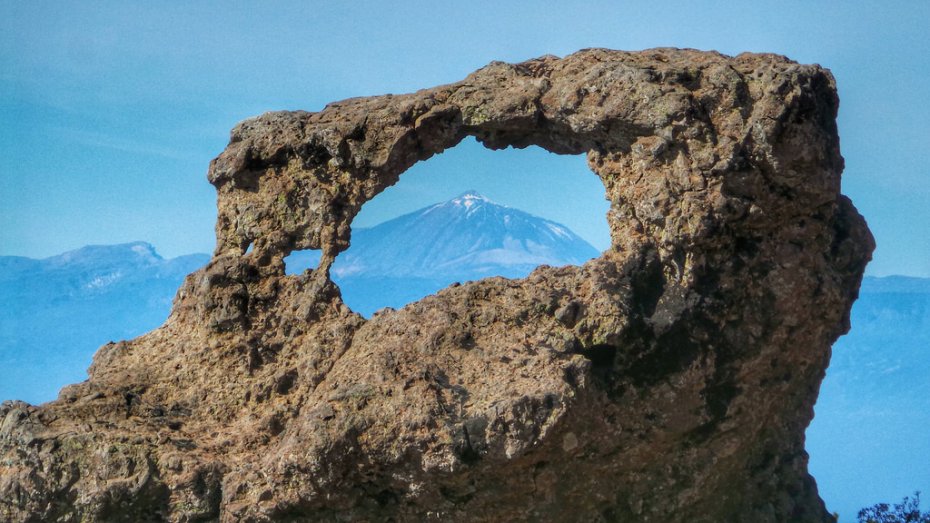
[285,191,600,316]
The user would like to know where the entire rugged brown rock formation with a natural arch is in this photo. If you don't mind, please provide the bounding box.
[0,49,873,522]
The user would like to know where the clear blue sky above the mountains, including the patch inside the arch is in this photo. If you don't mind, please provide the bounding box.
[0,0,930,276]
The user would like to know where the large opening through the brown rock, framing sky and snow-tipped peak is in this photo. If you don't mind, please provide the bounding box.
[326,138,610,317]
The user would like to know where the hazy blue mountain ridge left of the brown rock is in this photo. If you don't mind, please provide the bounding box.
[0,242,209,402]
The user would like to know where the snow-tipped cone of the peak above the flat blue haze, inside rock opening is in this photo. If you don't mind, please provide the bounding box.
[333,191,600,278]
